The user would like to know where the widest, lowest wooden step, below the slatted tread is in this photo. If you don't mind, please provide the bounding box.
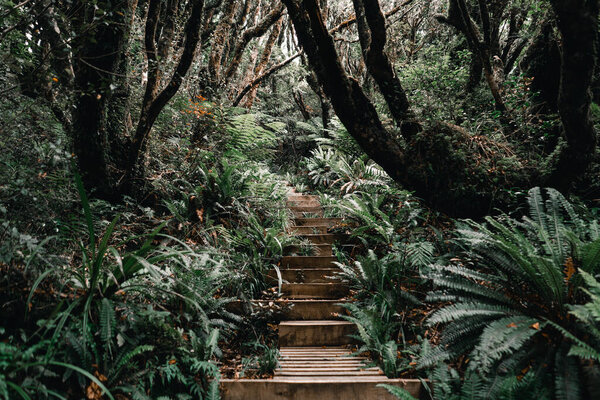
[220,375,425,400]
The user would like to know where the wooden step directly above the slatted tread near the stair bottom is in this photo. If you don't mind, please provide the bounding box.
[279,320,356,347]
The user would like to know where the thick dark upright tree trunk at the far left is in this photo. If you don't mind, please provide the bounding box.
[72,3,130,200]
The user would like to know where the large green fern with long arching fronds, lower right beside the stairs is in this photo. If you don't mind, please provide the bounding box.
[421,188,600,399]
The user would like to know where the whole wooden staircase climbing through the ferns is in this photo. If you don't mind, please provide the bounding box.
[222,194,421,400]
